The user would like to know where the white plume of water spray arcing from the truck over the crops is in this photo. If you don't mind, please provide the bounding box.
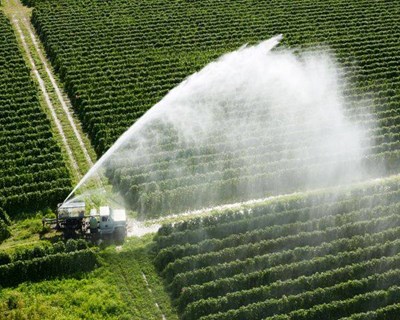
[67,36,376,216]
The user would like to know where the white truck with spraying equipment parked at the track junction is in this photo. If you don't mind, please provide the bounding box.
[43,201,127,242]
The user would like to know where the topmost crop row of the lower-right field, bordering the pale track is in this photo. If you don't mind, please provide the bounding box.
[156,188,400,251]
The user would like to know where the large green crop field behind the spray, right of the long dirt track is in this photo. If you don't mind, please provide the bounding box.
[28,0,400,216]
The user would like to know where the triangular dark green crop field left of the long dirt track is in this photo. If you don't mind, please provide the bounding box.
[0,12,71,215]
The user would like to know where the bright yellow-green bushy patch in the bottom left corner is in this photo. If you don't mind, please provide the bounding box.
[0,268,131,320]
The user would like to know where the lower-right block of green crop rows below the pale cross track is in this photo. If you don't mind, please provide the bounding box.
[154,178,400,319]
